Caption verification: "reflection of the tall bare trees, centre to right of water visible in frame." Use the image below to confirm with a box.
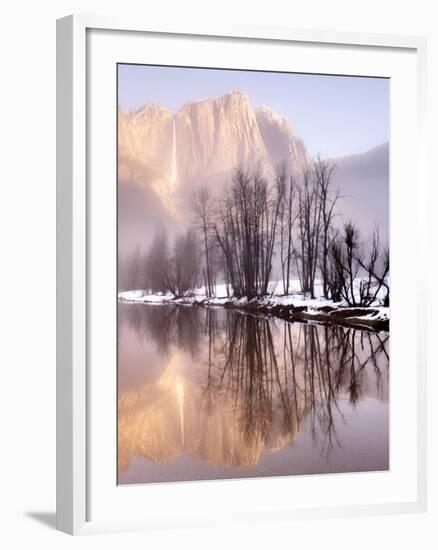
[197,310,389,455]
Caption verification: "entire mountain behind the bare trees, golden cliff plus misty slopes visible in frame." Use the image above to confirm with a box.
[118,92,389,254]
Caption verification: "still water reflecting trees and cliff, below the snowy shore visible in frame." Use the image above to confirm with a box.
[118,303,389,484]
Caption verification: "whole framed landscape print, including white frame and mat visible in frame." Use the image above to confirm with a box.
[57,16,426,534]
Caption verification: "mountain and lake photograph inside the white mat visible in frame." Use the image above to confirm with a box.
[116,63,390,485]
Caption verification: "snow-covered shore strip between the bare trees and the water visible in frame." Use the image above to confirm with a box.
[119,282,389,331]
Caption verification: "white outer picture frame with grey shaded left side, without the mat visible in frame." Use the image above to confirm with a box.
[56,15,427,534]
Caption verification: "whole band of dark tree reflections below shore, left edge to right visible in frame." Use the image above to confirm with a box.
[120,305,389,466]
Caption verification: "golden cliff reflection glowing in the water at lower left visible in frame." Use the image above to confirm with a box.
[118,352,304,473]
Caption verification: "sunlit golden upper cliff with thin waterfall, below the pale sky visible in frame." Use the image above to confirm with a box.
[118,92,308,209]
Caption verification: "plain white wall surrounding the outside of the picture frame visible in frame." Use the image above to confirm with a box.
[0,0,438,550]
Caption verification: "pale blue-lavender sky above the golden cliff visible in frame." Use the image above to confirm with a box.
[118,65,389,158]
